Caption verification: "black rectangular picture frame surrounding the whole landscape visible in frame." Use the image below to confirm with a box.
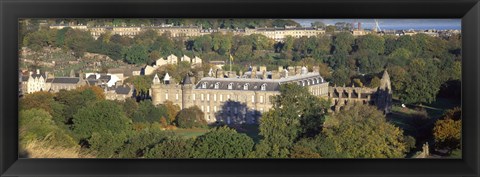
[0,0,480,176]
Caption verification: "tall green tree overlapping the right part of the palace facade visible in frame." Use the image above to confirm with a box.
[256,84,330,158]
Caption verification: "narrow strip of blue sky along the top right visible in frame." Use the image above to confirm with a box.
[293,19,461,30]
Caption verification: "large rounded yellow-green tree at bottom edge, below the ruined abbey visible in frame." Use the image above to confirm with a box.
[320,104,409,158]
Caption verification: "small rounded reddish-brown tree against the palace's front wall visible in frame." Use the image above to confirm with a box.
[176,106,207,128]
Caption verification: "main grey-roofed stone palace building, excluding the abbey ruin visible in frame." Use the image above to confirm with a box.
[152,67,328,124]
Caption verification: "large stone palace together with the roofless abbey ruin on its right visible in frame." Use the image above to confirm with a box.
[150,66,392,124]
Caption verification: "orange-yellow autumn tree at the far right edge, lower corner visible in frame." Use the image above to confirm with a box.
[433,107,462,152]
